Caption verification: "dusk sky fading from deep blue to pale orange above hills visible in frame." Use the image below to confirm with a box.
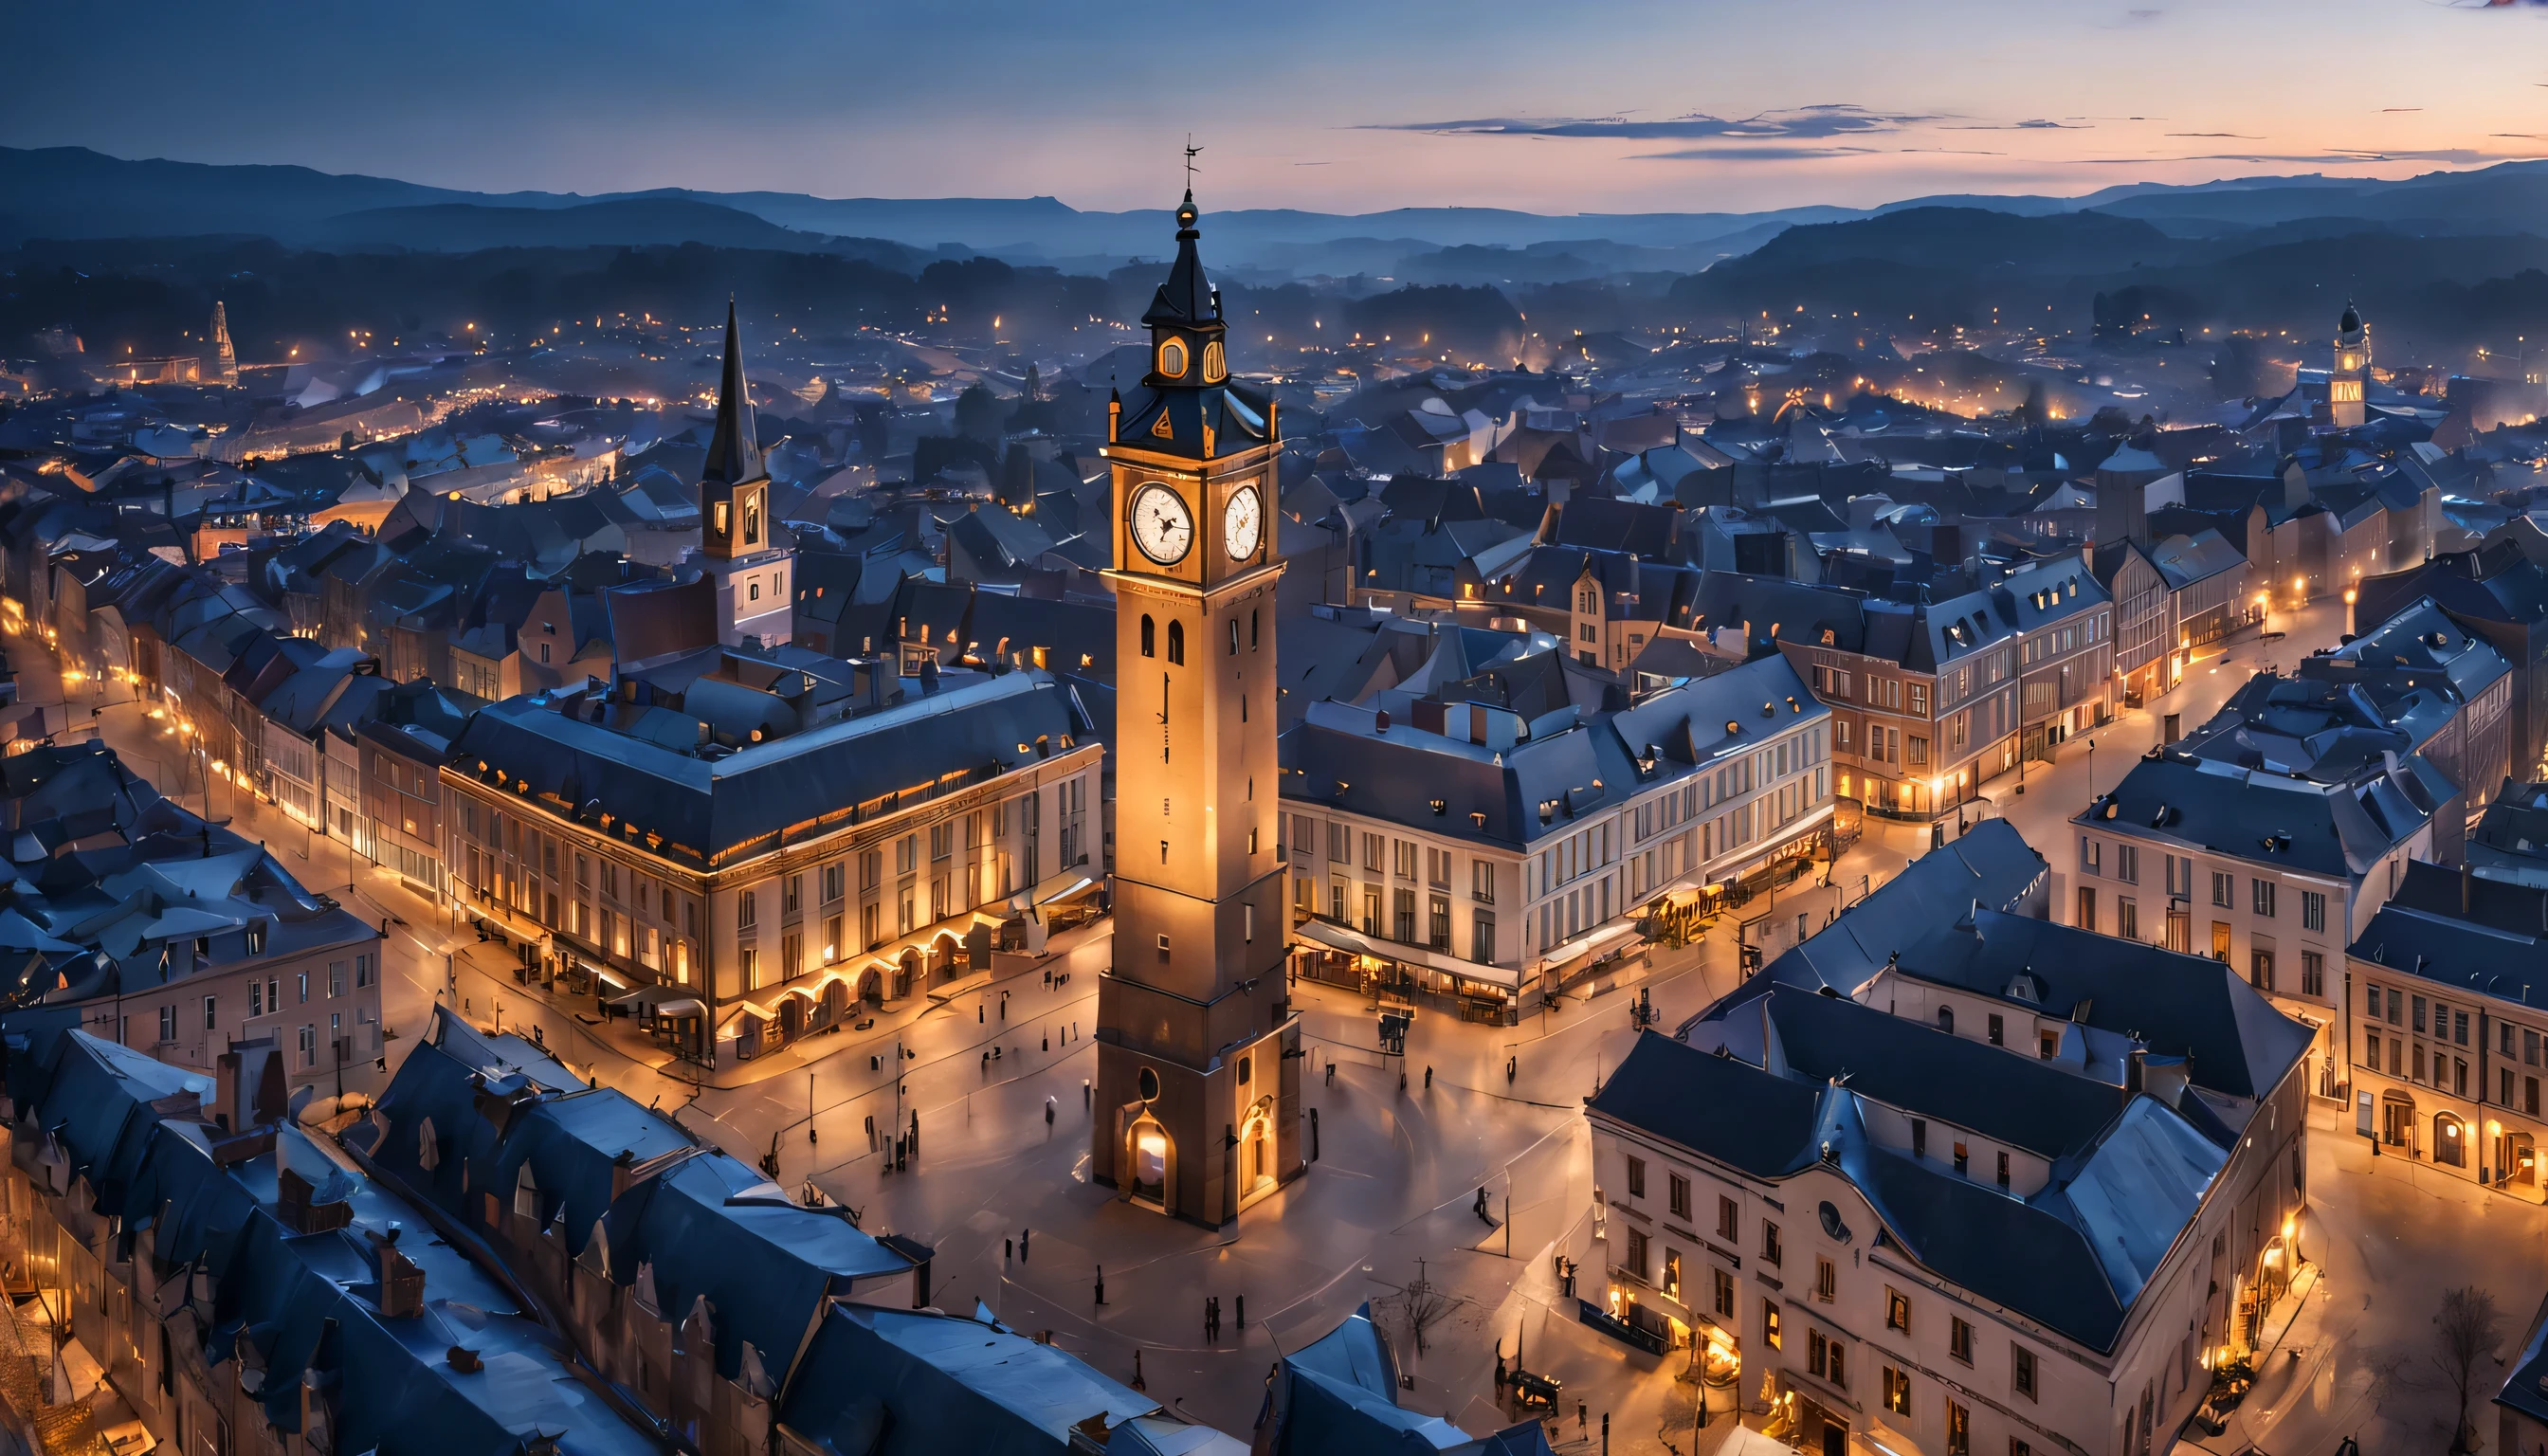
[20,0,2548,211]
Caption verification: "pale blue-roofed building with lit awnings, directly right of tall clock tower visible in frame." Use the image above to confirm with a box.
[1282,642,1832,1023]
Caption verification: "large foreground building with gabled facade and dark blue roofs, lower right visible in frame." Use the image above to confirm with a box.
[1585,910,2308,1456]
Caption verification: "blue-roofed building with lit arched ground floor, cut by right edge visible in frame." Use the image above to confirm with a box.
[2339,864,2548,1201]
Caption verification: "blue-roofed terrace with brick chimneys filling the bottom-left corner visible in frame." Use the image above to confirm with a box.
[0,1028,660,1456]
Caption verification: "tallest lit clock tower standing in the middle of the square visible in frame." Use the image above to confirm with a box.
[1090,191,1302,1227]
